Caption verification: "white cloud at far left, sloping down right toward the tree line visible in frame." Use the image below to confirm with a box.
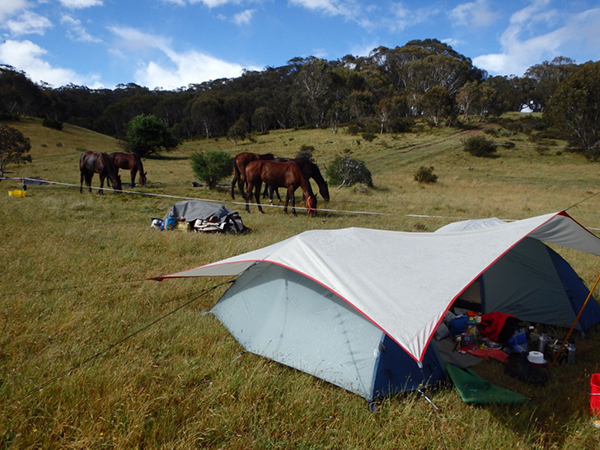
[0,40,100,88]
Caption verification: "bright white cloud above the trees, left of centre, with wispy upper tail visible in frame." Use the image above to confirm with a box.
[111,27,260,89]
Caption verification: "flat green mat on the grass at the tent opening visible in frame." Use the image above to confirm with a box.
[446,363,529,403]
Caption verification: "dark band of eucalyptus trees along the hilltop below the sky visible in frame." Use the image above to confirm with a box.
[0,39,600,153]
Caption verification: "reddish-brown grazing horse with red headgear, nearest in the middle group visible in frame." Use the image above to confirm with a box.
[244,160,317,217]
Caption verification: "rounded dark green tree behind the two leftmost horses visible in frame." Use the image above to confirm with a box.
[125,114,179,158]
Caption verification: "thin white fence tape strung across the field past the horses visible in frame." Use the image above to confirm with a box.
[5,177,600,231]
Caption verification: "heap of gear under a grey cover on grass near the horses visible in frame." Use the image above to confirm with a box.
[151,200,248,233]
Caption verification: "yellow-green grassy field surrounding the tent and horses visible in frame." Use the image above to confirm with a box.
[0,119,600,450]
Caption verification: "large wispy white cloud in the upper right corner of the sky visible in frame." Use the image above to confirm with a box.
[473,0,600,76]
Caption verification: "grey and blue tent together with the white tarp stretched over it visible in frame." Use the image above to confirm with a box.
[159,212,600,399]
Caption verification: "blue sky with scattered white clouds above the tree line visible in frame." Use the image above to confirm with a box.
[0,0,600,89]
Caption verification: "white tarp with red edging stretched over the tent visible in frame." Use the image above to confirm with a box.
[161,212,600,361]
